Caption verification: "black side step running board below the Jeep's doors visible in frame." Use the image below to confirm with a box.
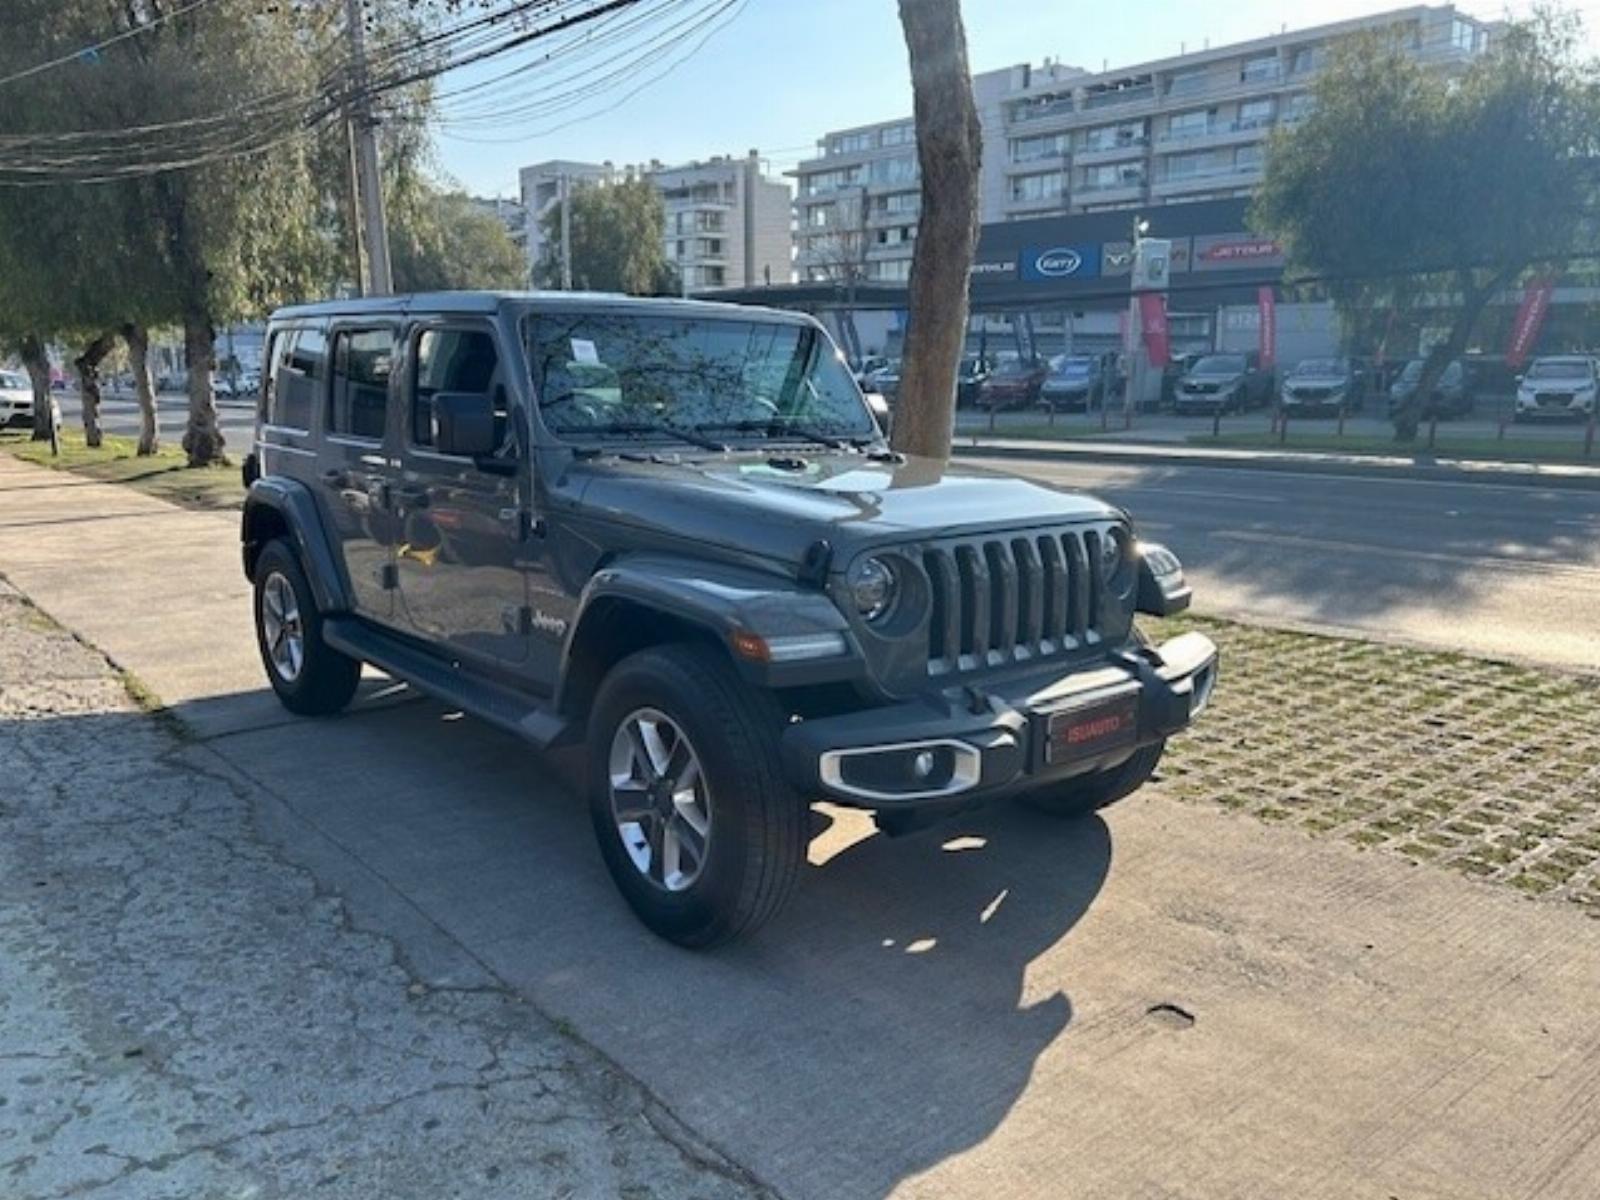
[322,618,576,750]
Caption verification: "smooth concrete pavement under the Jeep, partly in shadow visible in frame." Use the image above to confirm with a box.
[0,456,1600,1200]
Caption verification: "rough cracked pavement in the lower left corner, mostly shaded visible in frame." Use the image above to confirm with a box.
[0,584,758,1200]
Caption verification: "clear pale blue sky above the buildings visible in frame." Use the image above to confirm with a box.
[437,0,1548,195]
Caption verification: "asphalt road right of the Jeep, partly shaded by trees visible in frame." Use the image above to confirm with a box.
[965,459,1600,669]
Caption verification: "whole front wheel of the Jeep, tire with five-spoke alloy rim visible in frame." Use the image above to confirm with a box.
[589,645,806,947]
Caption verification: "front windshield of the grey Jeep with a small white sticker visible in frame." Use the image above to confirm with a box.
[523,312,877,440]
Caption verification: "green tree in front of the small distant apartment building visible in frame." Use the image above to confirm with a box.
[534,179,678,296]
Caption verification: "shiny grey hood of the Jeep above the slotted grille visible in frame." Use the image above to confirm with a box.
[558,451,1118,563]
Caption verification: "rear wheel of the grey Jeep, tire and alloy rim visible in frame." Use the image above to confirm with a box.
[256,539,362,717]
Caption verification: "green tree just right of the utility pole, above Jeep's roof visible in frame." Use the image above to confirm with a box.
[389,195,528,291]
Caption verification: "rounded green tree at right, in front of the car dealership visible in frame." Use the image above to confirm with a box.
[1251,18,1600,440]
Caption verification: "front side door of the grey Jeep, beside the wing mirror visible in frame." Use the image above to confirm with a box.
[394,322,528,664]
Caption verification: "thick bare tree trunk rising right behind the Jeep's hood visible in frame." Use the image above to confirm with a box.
[894,0,982,459]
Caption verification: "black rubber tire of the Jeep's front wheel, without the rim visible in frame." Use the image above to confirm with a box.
[589,643,808,949]
